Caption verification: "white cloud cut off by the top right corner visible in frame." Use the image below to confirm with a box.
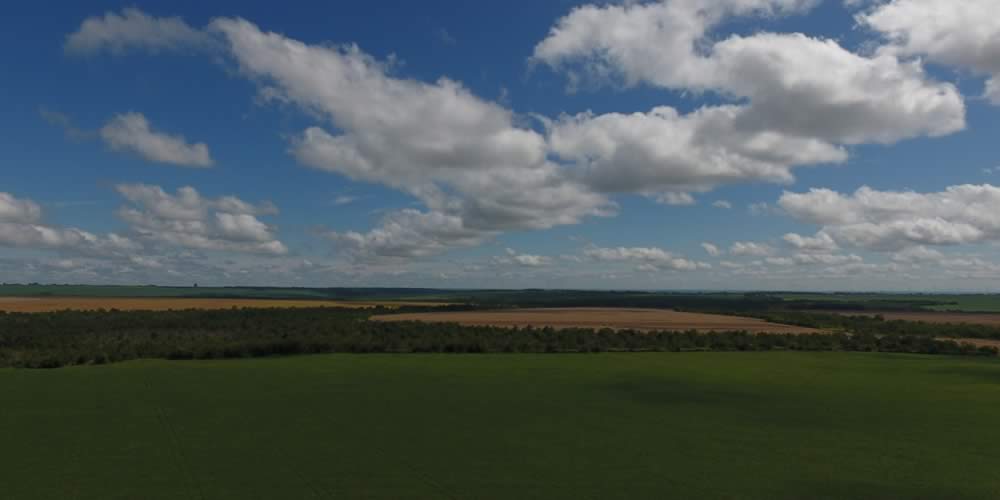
[857,0,1000,105]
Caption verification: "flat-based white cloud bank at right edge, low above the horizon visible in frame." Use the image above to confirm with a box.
[779,184,1000,251]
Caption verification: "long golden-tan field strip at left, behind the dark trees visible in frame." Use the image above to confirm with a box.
[0,297,440,312]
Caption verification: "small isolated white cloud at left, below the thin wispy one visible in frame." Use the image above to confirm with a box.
[100,113,214,167]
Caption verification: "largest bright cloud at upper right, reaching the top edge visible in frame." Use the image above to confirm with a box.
[533,0,964,148]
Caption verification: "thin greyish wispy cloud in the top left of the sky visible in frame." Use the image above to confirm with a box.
[64,8,212,55]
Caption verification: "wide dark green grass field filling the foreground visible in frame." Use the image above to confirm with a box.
[0,353,1000,499]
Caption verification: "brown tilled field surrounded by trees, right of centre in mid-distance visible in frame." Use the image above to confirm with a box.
[372,308,822,333]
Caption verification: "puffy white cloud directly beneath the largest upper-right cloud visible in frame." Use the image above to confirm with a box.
[549,106,847,196]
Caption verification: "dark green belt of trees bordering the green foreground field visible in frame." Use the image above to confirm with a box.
[0,308,997,368]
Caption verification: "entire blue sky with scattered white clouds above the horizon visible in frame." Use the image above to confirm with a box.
[0,0,1000,291]
